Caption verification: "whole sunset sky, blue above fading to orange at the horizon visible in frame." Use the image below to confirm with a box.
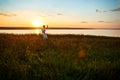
[0,0,120,28]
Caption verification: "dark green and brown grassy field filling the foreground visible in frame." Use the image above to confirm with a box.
[0,34,120,80]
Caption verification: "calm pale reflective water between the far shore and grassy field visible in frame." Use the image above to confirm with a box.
[0,29,120,37]
